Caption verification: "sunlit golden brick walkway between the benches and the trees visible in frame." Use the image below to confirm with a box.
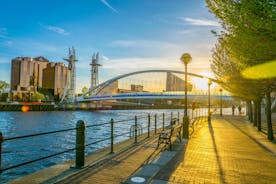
[153,117,276,184]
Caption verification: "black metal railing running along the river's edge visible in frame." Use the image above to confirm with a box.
[0,111,204,180]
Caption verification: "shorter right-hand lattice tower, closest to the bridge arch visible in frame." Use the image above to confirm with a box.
[90,53,101,89]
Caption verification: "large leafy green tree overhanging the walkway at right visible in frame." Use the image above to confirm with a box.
[206,0,276,140]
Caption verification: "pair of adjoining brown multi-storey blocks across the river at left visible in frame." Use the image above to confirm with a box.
[10,56,68,101]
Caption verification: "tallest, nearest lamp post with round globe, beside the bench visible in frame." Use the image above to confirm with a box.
[180,53,192,139]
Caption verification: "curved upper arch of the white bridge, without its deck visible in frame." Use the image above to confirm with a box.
[79,70,219,99]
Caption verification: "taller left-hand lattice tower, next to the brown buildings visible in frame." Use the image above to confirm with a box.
[61,47,78,103]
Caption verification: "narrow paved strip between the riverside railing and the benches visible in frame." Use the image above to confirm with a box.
[58,139,160,184]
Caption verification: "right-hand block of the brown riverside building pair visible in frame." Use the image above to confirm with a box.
[42,63,69,99]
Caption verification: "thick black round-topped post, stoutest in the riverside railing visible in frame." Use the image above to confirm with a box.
[75,120,85,169]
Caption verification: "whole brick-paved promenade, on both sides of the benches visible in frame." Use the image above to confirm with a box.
[11,116,276,184]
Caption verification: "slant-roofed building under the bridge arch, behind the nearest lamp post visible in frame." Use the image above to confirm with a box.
[166,72,192,92]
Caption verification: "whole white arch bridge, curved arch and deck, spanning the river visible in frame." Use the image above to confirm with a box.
[76,70,231,102]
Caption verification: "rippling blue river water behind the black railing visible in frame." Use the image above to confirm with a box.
[0,109,233,183]
